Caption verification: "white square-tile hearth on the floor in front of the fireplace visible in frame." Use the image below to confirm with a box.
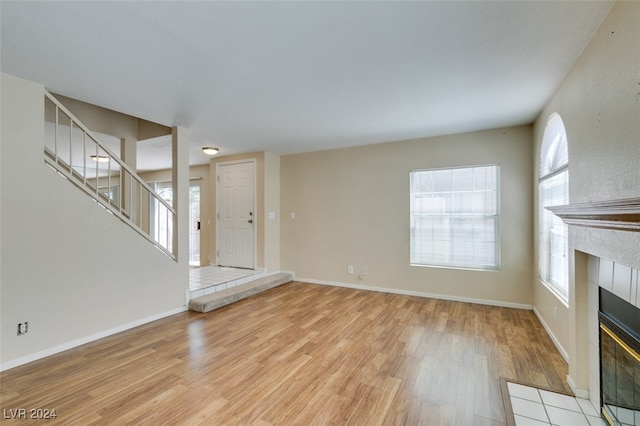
[507,382,606,426]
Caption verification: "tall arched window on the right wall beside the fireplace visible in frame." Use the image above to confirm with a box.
[538,113,569,303]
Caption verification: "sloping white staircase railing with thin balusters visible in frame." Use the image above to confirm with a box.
[44,91,176,260]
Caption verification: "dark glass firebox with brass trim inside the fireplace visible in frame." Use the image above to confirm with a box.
[598,287,640,426]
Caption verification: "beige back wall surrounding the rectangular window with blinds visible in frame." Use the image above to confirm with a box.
[281,126,533,305]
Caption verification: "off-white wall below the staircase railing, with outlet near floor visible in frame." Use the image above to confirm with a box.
[0,74,188,369]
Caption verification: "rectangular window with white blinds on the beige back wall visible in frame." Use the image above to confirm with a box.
[410,165,500,270]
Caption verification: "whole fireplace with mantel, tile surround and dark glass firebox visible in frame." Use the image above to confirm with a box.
[547,197,640,426]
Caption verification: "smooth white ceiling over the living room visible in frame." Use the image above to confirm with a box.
[0,1,613,168]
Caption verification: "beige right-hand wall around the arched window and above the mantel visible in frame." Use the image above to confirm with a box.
[534,1,640,389]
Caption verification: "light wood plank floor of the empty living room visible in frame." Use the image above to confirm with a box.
[0,282,569,426]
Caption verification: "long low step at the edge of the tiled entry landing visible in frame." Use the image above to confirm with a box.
[189,273,293,312]
